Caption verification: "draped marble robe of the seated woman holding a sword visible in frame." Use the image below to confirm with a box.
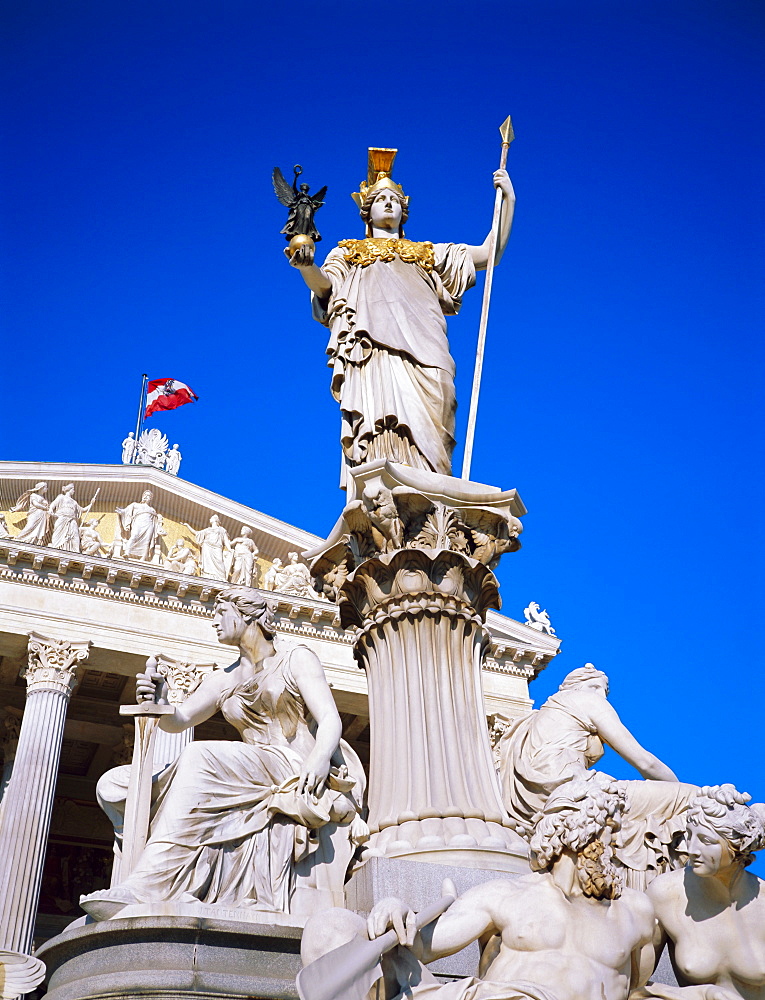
[89,649,367,919]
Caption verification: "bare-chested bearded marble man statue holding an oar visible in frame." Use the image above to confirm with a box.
[301,774,654,1000]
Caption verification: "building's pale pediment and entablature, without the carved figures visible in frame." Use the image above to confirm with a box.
[0,462,560,708]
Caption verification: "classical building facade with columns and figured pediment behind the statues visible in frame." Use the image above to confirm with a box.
[0,462,559,952]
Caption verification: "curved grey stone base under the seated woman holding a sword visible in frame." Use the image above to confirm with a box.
[40,907,301,1000]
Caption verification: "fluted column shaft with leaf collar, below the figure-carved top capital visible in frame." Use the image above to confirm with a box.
[350,549,515,856]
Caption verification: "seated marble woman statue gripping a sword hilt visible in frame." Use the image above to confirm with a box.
[81,589,366,920]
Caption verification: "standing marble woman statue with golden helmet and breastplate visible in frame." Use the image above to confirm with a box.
[289,150,515,487]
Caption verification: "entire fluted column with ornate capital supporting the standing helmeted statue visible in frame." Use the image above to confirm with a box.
[306,461,527,870]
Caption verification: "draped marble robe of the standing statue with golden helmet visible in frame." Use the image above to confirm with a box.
[313,241,475,487]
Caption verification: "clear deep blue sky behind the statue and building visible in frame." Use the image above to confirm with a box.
[0,0,765,868]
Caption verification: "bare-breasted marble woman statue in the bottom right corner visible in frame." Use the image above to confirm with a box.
[635,785,765,1000]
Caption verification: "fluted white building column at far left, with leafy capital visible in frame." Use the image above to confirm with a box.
[0,632,91,995]
